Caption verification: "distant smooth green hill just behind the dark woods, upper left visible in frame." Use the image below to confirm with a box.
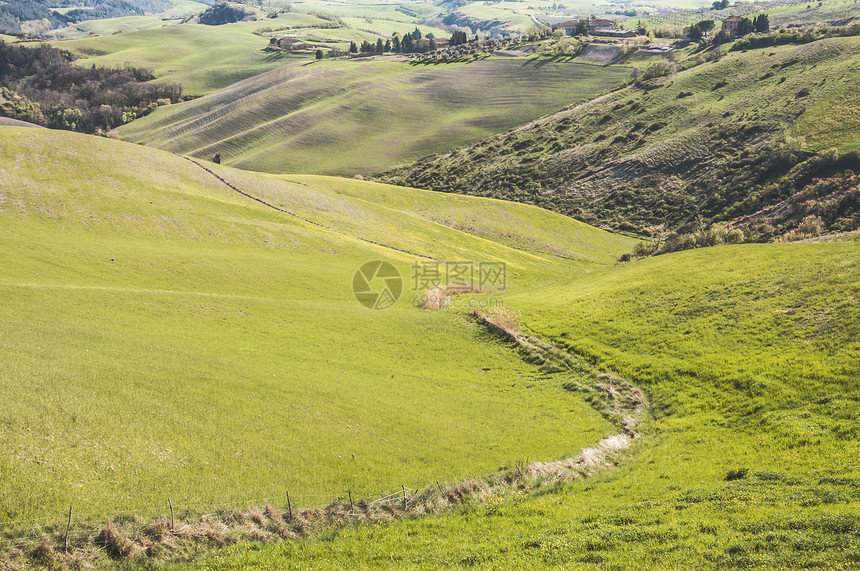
[47,12,445,96]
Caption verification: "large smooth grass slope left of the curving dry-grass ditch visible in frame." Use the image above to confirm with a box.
[0,128,631,529]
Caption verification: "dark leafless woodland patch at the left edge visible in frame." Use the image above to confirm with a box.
[0,41,182,133]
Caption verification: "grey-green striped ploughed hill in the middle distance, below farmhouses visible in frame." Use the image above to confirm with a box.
[116,58,630,176]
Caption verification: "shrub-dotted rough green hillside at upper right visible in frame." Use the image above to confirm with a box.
[379,37,860,238]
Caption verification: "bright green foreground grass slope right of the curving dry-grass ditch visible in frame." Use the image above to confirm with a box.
[178,237,860,569]
